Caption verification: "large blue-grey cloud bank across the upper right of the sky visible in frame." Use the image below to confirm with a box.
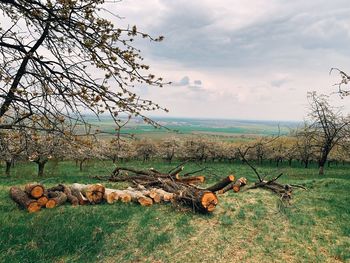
[144,0,350,68]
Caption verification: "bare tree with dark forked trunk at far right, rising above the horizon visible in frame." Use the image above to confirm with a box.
[309,92,350,175]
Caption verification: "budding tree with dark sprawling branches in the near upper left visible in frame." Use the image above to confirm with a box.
[0,0,166,132]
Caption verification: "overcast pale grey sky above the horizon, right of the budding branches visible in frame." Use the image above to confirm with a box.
[106,0,350,121]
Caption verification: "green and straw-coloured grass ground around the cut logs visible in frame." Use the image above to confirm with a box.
[0,161,350,263]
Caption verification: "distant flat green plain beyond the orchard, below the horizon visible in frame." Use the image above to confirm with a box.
[84,117,299,139]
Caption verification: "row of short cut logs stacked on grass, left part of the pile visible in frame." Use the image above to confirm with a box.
[10,183,179,213]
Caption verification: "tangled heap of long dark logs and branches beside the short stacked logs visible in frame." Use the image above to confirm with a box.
[95,166,246,213]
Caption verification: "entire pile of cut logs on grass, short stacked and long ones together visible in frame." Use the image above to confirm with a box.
[10,168,247,213]
